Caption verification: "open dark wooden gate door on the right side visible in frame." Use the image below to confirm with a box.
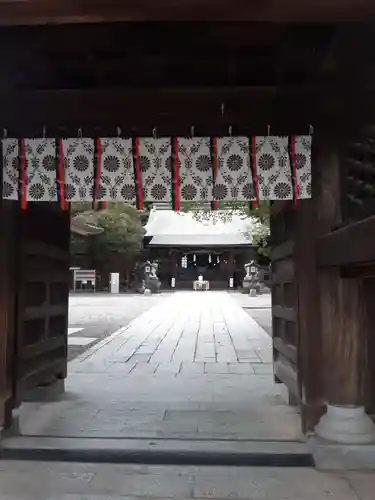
[271,200,322,432]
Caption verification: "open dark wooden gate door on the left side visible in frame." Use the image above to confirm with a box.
[14,203,70,405]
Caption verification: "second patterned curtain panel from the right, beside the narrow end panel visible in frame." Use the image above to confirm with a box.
[256,136,293,200]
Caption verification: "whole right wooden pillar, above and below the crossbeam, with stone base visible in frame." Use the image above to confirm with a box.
[314,131,375,443]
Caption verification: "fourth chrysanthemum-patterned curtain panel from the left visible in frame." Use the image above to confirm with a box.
[96,137,136,202]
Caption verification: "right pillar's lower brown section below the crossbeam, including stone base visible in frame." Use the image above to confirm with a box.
[315,269,375,443]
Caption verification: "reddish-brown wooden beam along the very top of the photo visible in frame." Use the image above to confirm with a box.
[0,0,374,25]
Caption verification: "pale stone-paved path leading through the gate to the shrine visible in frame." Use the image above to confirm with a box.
[17,292,302,440]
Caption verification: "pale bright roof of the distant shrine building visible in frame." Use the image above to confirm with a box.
[145,209,259,247]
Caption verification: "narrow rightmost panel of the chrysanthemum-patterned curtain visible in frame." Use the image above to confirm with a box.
[295,135,312,199]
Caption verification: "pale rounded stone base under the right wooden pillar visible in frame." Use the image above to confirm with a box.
[315,405,375,444]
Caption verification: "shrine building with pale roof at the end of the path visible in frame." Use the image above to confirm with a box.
[145,205,257,290]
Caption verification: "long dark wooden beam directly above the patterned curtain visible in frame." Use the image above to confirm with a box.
[0,87,334,136]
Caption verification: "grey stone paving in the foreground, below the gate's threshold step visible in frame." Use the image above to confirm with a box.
[0,461,375,500]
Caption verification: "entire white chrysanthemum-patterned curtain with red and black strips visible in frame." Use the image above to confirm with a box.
[2,135,312,203]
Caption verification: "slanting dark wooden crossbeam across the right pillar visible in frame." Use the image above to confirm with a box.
[318,216,375,267]
